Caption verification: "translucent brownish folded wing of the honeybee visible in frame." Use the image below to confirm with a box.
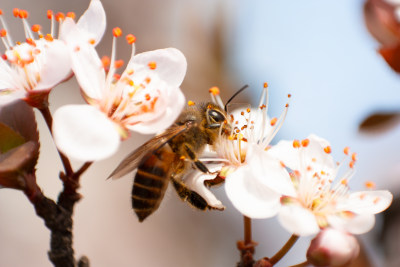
[107,124,189,179]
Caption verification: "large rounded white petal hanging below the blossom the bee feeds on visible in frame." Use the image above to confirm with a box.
[225,165,281,219]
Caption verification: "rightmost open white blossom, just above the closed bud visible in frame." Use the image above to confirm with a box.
[264,135,393,236]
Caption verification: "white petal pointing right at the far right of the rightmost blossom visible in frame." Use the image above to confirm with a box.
[337,190,393,214]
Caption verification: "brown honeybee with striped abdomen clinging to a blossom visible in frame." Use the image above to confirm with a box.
[109,103,231,222]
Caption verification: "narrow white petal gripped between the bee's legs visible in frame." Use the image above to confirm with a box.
[184,164,225,210]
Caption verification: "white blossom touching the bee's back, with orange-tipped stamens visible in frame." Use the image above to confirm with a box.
[53,21,187,161]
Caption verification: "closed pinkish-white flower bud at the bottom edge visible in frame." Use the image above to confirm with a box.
[307,228,360,267]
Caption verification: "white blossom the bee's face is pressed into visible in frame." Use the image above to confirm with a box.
[215,85,293,218]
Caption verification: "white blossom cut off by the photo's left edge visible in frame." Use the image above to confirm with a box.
[0,0,105,107]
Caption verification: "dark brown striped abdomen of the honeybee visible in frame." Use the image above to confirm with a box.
[132,144,179,222]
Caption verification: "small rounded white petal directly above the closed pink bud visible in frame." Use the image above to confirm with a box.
[278,205,319,236]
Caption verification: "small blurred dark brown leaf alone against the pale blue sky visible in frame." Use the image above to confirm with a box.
[359,112,400,133]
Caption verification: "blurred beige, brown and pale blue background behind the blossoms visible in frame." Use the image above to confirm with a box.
[0,0,400,267]
